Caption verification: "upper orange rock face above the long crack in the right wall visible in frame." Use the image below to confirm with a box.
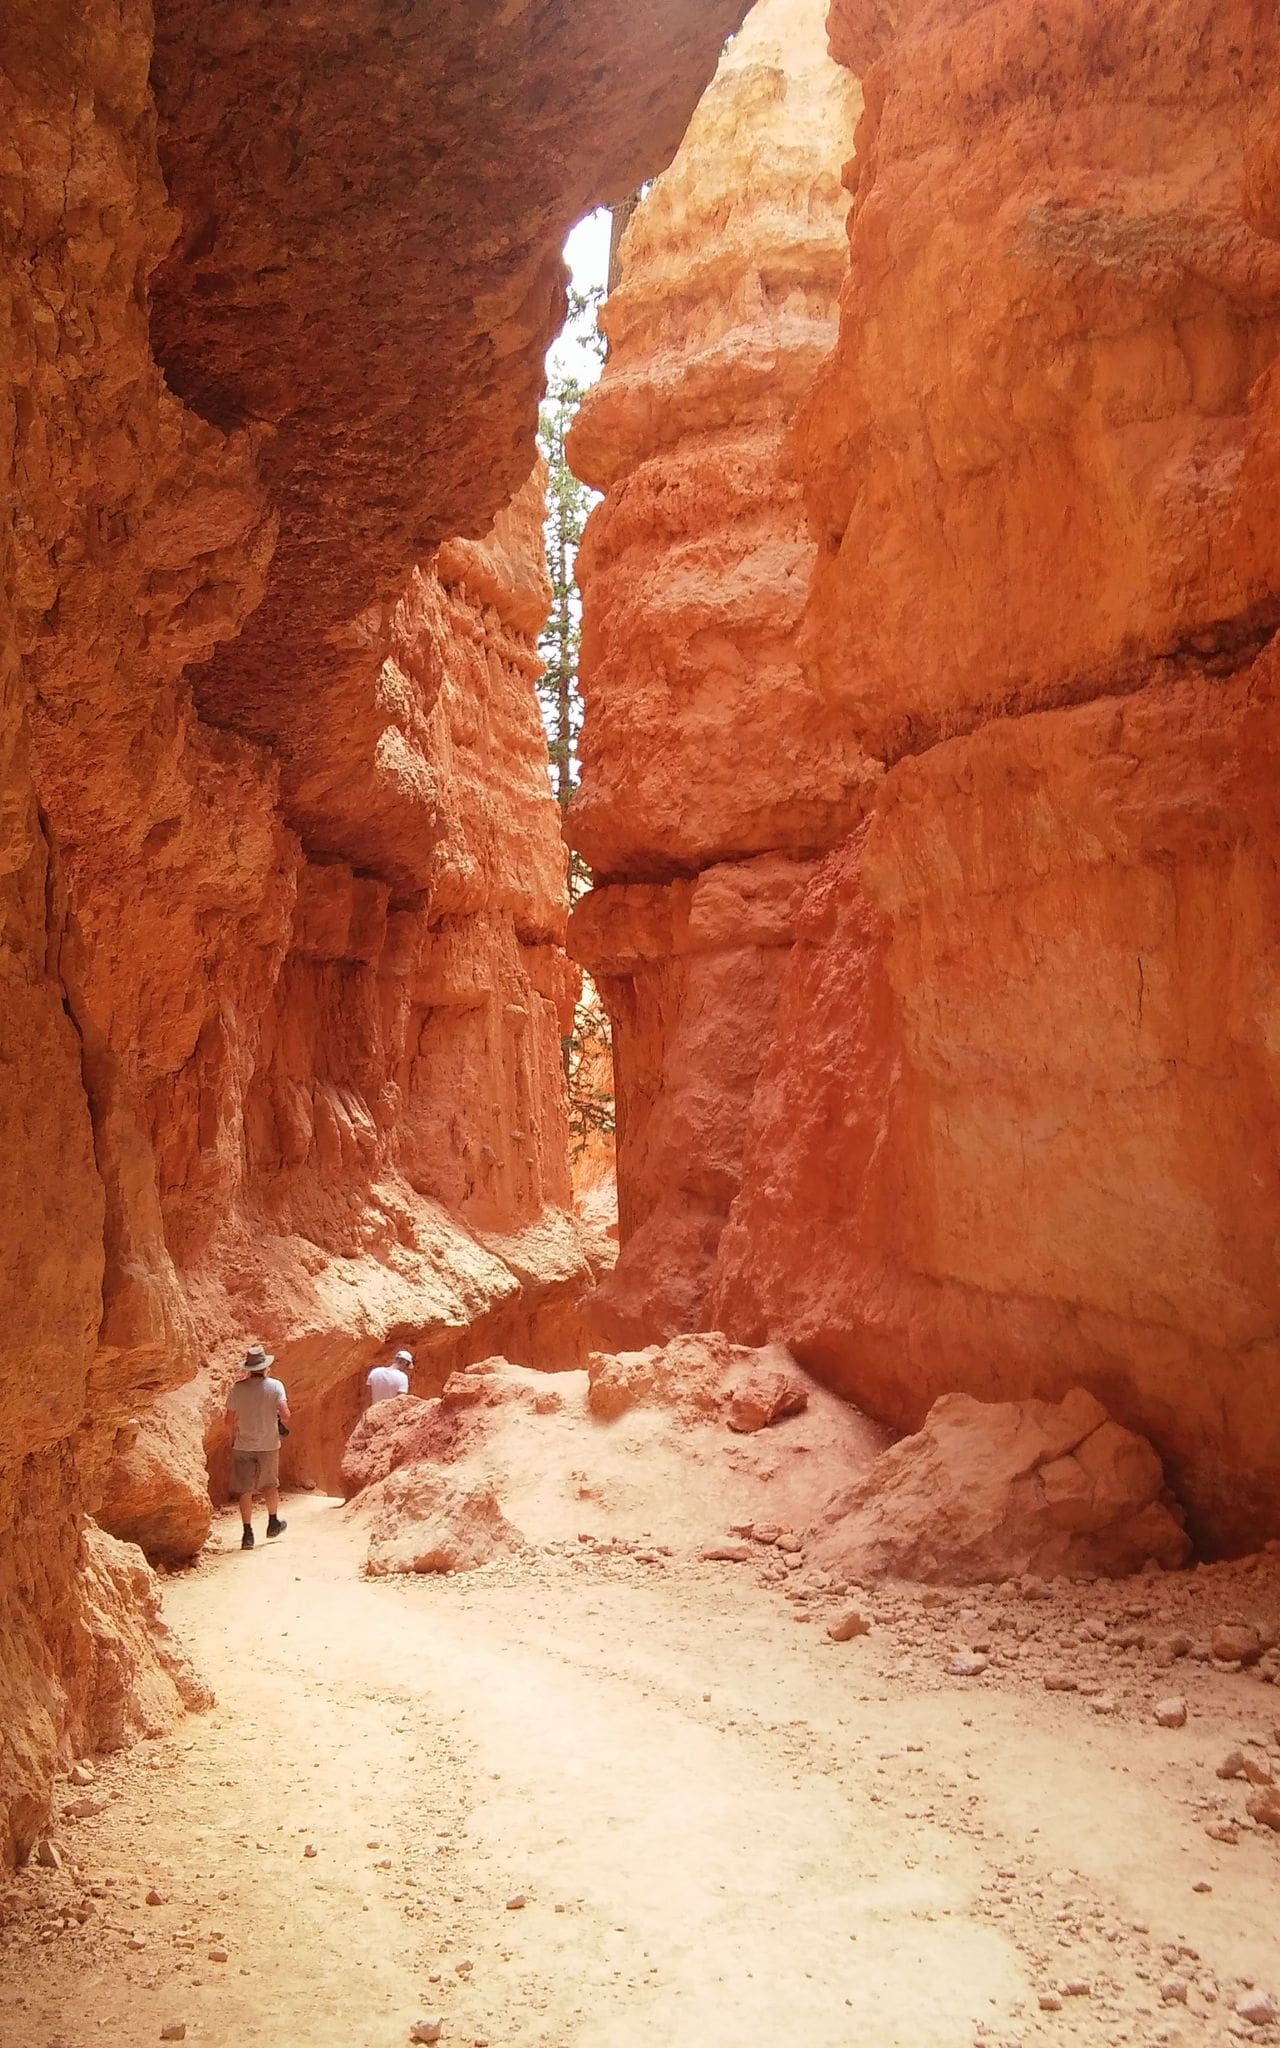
[799,0,1280,758]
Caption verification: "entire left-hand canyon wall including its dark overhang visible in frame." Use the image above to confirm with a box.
[0,0,741,1853]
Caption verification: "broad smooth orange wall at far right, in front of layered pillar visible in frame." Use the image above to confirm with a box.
[573,0,1280,1546]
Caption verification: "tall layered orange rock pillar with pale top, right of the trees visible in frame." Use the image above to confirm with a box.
[569,0,870,1343]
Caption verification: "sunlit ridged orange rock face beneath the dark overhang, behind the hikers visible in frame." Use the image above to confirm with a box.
[102,468,588,1523]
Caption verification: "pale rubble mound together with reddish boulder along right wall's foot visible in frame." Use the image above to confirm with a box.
[342,1331,1190,1583]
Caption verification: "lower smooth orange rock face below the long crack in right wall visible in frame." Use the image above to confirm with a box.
[719,664,1280,1540]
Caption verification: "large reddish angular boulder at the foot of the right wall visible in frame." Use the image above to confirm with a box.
[815,1389,1190,1585]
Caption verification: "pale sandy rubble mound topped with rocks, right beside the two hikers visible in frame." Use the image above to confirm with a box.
[342,1331,885,1573]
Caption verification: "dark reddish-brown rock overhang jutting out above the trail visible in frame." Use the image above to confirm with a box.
[154,0,745,881]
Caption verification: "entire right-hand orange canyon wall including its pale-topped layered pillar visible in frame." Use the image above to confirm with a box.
[573,0,1280,1546]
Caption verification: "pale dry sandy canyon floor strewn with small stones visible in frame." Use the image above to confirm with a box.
[0,1497,1280,2048]
